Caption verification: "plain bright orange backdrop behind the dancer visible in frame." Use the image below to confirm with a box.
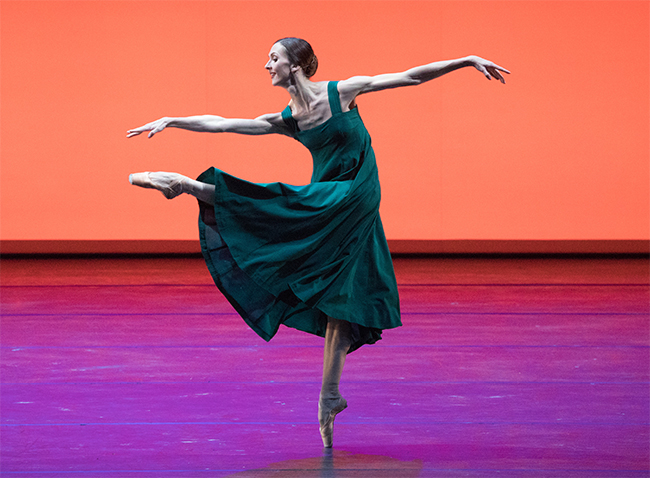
[0,0,650,239]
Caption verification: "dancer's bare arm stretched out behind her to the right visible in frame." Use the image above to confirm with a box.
[339,56,510,101]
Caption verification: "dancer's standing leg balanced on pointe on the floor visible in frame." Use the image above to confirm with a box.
[318,317,352,447]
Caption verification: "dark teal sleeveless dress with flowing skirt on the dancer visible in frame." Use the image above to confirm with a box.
[198,82,401,352]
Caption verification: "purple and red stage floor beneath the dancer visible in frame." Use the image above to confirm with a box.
[0,257,650,478]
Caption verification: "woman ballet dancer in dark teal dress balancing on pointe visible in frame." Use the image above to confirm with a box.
[128,38,509,447]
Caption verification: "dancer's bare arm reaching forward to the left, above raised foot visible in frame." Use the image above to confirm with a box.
[126,113,291,138]
